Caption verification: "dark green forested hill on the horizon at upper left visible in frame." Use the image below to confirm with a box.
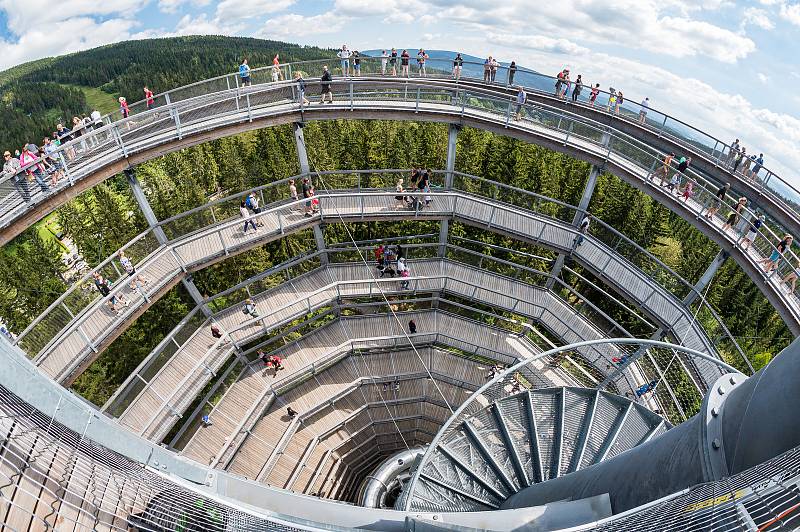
[0,36,333,150]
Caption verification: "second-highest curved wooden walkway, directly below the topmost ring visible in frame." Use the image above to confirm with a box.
[21,192,728,385]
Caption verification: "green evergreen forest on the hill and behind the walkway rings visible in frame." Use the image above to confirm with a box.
[0,37,791,405]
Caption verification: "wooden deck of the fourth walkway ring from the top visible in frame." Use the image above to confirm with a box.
[177,311,566,463]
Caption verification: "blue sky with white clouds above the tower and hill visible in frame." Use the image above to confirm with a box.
[0,0,800,188]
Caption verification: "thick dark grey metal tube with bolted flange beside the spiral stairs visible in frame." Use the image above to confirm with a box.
[502,340,800,513]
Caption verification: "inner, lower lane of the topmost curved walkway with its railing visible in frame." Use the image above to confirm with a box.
[0,80,800,334]
